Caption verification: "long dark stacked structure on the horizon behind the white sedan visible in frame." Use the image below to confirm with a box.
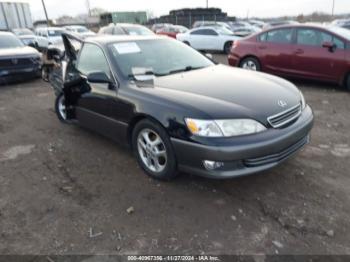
[148,8,236,27]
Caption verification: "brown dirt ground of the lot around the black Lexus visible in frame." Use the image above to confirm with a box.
[0,53,350,254]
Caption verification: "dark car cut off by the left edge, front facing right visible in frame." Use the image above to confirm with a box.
[0,32,41,84]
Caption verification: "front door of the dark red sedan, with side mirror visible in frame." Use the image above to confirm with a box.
[294,28,346,81]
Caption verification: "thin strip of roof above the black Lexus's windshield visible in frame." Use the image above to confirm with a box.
[84,35,169,45]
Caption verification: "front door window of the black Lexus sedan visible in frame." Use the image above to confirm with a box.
[77,44,111,76]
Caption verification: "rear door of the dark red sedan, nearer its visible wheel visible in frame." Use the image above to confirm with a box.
[257,27,294,74]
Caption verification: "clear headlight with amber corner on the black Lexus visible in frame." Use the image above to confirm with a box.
[186,118,266,137]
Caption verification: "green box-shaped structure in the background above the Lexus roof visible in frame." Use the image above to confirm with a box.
[100,12,147,25]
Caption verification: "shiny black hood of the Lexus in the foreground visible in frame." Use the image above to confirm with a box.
[148,65,301,123]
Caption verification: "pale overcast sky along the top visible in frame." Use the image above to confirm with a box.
[13,0,350,20]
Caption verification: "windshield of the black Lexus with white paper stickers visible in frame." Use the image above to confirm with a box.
[109,39,214,78]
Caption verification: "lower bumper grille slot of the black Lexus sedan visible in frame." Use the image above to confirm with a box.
[244,136,309,167]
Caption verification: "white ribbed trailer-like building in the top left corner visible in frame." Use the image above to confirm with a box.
[0,1,33,30]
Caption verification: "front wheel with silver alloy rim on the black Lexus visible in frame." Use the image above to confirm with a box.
[132,119,177,180]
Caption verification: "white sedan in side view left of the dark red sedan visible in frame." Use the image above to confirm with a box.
[176,27,241,54]
